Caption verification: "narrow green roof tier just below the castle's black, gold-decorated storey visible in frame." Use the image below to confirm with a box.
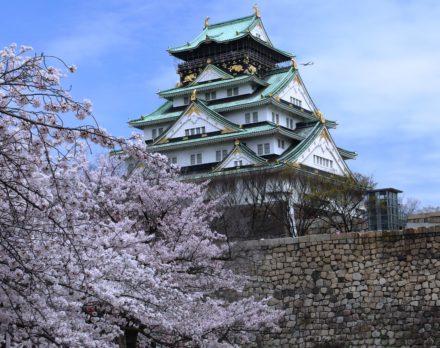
[158,75,268,98]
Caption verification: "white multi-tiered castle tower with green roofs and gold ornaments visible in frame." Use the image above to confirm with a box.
[129,6,356,179]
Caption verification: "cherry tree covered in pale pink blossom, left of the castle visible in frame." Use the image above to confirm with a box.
[0,45,280,347]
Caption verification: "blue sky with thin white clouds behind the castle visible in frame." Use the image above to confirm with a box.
[0,0,440,206]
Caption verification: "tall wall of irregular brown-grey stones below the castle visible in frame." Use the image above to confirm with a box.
[232,226,440,347]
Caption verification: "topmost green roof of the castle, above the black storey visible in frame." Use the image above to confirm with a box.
[168,15,293,58]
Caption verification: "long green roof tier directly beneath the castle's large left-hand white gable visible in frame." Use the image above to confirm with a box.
[149,123,303,151]
